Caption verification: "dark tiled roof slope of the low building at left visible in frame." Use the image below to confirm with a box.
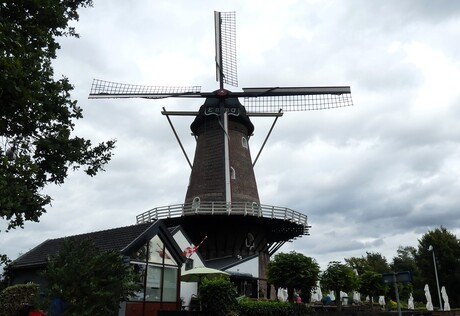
[13,223,154,268]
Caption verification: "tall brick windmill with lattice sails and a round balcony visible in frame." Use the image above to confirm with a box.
[89,12,352,286]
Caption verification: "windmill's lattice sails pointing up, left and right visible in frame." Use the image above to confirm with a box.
[89,11,353,113]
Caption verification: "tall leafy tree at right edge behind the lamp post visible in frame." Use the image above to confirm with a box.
[415,226,460,307]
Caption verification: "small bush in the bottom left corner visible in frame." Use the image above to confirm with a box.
[0,284,38,316]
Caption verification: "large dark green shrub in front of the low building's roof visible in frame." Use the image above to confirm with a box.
[44,239,136,316]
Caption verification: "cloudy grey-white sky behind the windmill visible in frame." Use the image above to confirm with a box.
[0,0,460,268]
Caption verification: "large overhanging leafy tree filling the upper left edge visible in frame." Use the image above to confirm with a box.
[0,0,114,229]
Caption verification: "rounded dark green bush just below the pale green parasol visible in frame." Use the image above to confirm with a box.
[199,277,238,316]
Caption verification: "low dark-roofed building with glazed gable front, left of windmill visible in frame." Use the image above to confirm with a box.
[9,220,196,316]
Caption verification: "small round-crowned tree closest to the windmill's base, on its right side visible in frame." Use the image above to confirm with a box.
[267,251,320,298]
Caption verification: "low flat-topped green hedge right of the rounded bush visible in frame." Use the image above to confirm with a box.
[238,299,311,316]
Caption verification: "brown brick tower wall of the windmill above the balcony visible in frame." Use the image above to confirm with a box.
[185,105,260,204]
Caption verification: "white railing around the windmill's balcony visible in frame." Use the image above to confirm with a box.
[136,201,310,234]
